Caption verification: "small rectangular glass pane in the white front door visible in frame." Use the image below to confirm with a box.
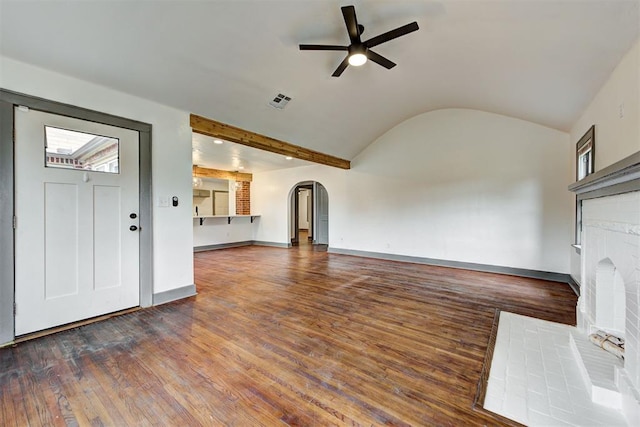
[44,126,120,173]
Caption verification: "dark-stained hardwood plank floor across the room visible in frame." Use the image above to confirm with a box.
[0,246,576,426]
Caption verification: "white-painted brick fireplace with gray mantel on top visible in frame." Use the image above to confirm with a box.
[569,153,640,425]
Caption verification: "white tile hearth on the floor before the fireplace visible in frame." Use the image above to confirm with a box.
[483,311,627,426]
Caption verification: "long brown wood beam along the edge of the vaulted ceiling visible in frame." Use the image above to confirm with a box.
[190,114,351,169]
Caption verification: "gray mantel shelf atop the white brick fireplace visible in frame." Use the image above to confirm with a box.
[569,152,640,200]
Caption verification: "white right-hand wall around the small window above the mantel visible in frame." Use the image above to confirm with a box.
[569,40,640,282]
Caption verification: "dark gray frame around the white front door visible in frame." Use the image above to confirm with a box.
[0,88,153,345]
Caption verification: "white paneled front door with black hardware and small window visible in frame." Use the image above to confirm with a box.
[15,108,140,336]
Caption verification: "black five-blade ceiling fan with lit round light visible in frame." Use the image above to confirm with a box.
[300,6,418,77]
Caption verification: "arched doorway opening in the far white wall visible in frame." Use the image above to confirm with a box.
[289,181,329,247]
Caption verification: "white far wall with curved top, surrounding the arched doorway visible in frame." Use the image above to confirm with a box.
[251,109,572,273]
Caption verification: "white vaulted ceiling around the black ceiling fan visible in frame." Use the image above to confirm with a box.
[0,0,640,171]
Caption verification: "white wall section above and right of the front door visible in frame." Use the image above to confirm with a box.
[0,57,193,293]
